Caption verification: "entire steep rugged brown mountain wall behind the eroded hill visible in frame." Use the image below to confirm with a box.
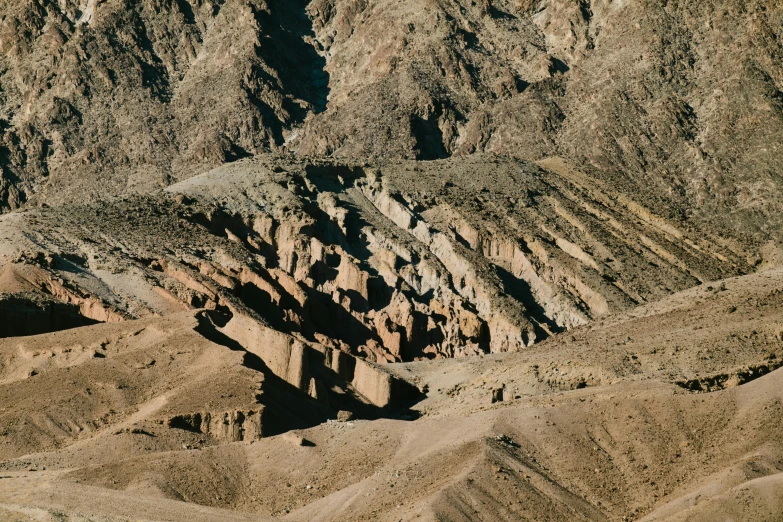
[0,0,783,242]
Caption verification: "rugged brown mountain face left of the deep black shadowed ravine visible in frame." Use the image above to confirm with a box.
[0,0,326,208]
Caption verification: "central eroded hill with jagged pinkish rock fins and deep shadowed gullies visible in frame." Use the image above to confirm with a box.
[0,156,749,368]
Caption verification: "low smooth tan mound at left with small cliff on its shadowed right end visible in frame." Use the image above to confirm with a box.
[0,308,336,458]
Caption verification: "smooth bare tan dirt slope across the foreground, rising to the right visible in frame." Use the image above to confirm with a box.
[0,270,783,520]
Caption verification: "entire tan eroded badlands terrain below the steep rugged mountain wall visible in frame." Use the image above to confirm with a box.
[0,155,783,520]
